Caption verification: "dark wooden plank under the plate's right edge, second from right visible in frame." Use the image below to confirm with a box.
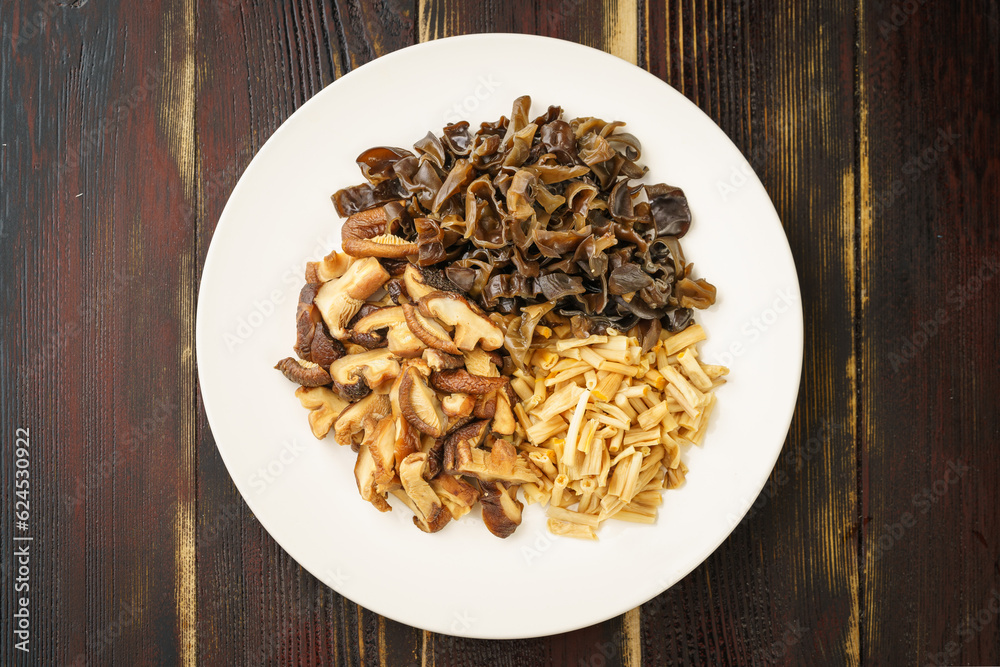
[639,0,859,665]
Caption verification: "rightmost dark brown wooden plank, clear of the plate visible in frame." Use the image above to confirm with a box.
[858,1,1000,665]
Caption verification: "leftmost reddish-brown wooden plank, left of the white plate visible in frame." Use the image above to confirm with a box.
[0,0,195,664]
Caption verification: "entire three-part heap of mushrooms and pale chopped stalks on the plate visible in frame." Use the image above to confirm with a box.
[276,97,726,539]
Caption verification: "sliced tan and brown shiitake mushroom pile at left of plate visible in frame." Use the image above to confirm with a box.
[276,252,540,537]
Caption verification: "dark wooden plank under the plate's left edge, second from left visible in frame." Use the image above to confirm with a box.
[195,0,423,665]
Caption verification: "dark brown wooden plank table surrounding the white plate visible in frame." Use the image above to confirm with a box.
[0,0,1000,667]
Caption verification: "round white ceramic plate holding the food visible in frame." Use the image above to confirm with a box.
[197,35,802,639]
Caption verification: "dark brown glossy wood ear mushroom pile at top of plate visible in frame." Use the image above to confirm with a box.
[333,96,715,367]
